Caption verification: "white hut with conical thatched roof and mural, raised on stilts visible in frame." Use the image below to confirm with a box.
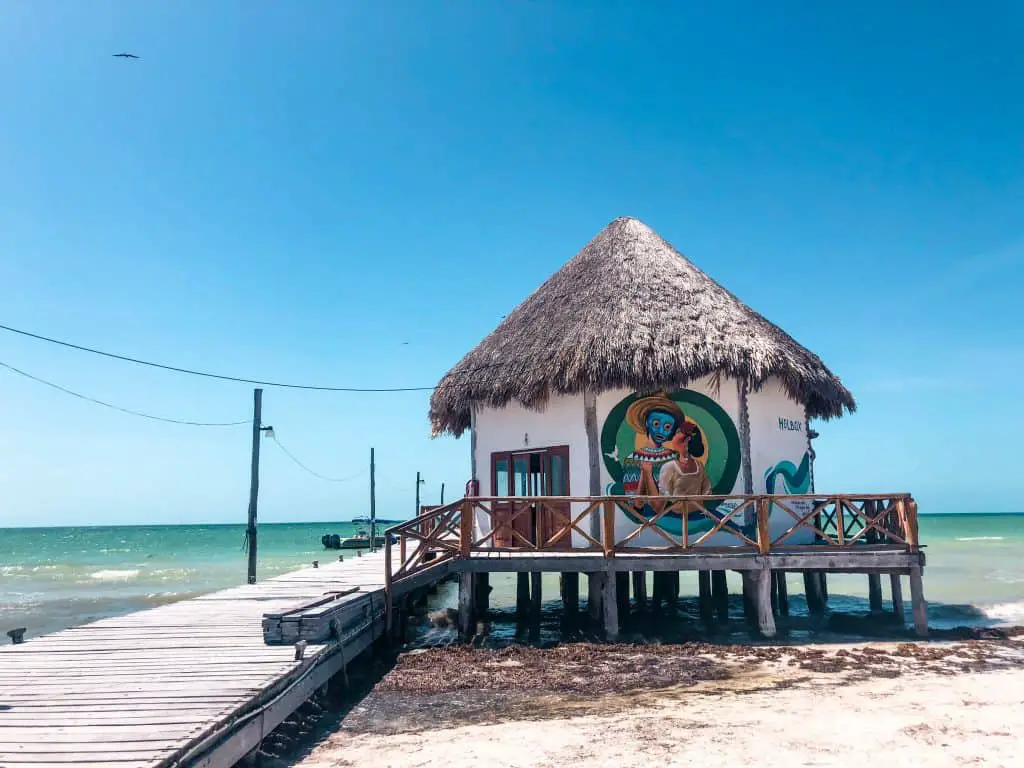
[385,218,923,634]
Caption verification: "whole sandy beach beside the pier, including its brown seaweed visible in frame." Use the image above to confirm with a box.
[263,636,1024,768]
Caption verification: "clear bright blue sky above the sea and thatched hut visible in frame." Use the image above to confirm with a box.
[0,0,1024,525]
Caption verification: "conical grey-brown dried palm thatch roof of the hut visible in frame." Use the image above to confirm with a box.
[430,218,856,435]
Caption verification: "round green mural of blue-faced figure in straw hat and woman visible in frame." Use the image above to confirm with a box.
[601,389,740,536]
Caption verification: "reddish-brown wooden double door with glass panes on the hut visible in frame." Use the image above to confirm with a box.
[490,445,572,549]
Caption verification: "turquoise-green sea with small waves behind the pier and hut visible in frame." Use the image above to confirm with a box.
[0,514,1024,635]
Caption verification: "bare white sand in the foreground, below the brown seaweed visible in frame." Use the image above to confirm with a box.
[288,668,1024,768]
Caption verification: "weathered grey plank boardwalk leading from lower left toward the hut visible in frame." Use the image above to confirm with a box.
[0,553,397,768]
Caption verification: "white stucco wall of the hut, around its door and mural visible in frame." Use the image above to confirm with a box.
[475,378,823,546]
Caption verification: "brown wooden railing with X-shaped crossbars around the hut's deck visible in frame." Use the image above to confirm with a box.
[385,494,920,583]
